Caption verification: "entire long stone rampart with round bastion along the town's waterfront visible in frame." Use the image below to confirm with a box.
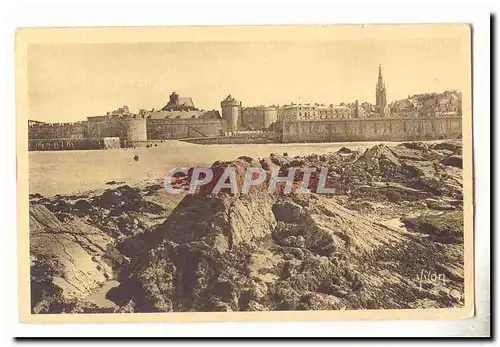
[28,117,462,151]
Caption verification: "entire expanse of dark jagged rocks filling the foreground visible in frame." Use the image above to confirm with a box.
[30,141,464,313]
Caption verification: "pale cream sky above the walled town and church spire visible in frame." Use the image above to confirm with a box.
[27,38,464,122]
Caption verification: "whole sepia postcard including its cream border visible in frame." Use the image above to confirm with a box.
[16,24,474,322]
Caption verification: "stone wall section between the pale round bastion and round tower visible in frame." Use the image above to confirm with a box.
[147,119,226,140]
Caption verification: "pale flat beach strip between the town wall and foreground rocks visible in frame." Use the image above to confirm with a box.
[29,140,459,196]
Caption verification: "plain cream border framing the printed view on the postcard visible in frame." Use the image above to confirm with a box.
[16,24,474,323]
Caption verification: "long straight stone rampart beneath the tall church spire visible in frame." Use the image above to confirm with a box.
[282,117,462,143]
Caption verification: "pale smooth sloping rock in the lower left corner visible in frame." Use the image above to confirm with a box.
[30,205,114,312]
